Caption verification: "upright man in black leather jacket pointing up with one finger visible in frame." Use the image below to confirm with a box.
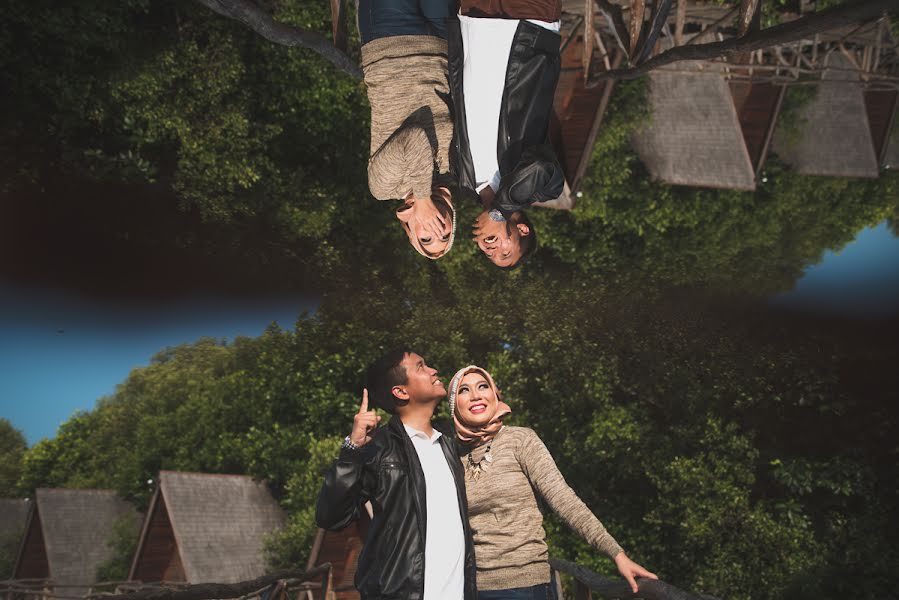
[315,350,477,600]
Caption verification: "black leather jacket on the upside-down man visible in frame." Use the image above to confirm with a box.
[447,12,565,218]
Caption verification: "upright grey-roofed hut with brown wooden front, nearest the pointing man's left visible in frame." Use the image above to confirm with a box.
[128,471,285,583]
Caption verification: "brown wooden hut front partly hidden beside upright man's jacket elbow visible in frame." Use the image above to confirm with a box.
[306,513,370,600]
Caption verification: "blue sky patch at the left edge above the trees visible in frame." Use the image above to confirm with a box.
[0,280,315,445]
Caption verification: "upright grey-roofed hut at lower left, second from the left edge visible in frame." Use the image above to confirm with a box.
[13,489,135,586]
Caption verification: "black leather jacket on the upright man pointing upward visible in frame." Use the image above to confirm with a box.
[315,417,477,600]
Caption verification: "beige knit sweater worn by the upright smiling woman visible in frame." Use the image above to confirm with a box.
[462,426,621,590]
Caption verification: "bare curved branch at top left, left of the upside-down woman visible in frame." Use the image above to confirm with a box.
[196,0,362,79]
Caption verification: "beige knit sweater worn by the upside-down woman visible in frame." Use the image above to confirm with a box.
[362,35,453,200]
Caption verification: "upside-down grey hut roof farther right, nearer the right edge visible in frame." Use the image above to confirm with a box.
[774,52,878,178]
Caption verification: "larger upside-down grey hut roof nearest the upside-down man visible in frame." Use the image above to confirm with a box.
[632,62,755,190]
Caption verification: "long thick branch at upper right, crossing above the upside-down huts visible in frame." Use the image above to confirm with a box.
[588,0,897,86]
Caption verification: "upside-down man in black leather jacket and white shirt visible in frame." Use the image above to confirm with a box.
[447,5,565,267]
